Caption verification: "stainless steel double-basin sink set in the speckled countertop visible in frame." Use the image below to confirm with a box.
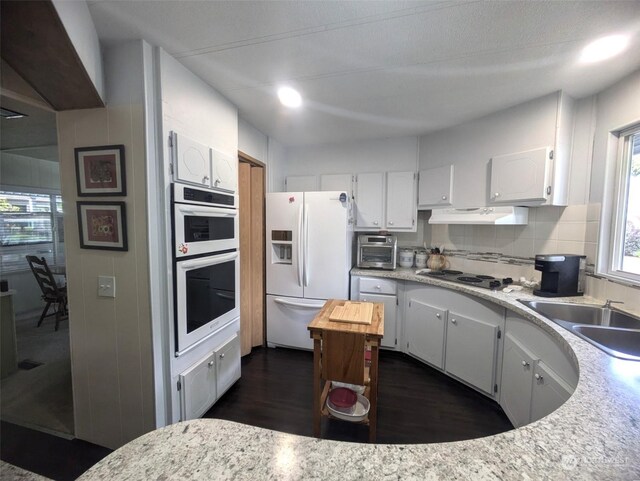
[519,299,640,361]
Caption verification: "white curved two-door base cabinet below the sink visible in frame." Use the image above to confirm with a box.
[500,313,578,427]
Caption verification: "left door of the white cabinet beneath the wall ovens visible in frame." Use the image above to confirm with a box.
[180,348,217,421]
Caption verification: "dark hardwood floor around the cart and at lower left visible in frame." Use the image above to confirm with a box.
[0,348,513,480]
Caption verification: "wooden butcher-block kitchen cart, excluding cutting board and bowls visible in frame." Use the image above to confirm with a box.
[308,299,384,442]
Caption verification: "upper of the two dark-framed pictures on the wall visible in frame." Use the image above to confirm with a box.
[75,145,127,197]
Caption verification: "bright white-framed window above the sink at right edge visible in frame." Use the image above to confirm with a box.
[607,125,640,284]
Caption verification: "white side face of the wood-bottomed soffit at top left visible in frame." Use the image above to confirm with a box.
[53,0,105,100]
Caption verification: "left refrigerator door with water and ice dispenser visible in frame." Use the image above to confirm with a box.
[265,192,304,297]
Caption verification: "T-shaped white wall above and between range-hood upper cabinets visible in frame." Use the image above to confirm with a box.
[419,93,558,208]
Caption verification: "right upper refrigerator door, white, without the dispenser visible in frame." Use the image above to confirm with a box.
[302,191,353,299]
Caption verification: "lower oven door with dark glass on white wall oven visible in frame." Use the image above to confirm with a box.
[175,251,240,355]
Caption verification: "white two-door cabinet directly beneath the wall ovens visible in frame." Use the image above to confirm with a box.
[180,334,240,421]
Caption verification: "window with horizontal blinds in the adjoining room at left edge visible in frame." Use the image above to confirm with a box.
[0,191,64,272]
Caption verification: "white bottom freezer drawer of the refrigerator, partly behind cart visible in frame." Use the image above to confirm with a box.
[267,296,325,349]
